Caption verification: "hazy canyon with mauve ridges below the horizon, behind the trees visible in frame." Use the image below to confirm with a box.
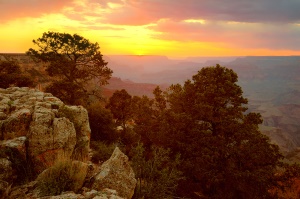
[0,54,300,160]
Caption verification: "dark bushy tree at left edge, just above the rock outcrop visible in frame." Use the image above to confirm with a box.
[0,61,36,88]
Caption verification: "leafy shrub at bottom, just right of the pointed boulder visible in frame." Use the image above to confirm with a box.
[131,144,183,199]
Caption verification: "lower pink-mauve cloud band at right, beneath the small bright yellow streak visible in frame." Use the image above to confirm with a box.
[152,19,300,50]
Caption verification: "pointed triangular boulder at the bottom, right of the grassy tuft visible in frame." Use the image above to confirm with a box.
[92,147,136,199]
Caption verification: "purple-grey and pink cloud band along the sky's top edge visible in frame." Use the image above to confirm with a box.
[102,0,300,25]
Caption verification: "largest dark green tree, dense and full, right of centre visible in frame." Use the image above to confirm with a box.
[157,65,282,198]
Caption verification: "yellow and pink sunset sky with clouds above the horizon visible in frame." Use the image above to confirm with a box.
[0,0,300,58]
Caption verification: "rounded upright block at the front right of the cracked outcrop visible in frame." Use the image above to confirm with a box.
[28,113,76,171]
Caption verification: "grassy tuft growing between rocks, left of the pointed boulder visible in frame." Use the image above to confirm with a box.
[37,158,88,196]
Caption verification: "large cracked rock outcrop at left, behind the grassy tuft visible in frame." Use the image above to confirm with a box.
[0,87,90,180]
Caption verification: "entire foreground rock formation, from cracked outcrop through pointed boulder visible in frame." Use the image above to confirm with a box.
[0,87,136,199]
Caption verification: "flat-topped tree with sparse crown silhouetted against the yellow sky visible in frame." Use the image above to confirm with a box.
[27,32,112,104]
